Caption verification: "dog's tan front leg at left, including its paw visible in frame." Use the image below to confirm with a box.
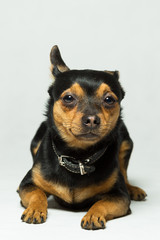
[18,171,48,223]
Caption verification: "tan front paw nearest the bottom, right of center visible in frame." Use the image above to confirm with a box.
[81,212,106,230]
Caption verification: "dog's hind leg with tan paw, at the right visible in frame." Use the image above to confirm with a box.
[119,126,147,201]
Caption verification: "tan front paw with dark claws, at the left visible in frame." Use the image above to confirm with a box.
[21,205,47,224]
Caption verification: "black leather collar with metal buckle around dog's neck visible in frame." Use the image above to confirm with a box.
[52,140,108,175]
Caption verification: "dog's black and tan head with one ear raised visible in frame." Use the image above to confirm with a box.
[49,46,124,149]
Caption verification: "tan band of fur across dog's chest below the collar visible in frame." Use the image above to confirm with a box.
[32,167,117,203]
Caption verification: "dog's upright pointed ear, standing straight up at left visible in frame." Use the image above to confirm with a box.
[50,45,70,77]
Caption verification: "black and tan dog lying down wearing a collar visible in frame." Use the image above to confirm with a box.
[19,46,146,229]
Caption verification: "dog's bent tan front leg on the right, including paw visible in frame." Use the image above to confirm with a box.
[81,197,130,230]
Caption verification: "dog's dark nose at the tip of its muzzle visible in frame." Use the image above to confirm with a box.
[82,115,100,129]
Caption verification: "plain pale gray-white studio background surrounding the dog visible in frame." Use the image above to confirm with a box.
[0,0,160,239]
